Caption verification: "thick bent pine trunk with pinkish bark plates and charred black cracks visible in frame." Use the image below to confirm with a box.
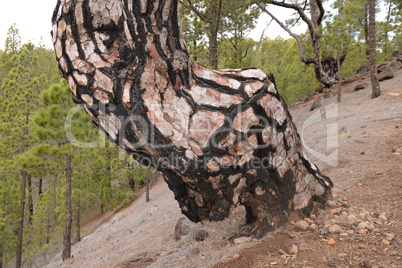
[53,0,332,237]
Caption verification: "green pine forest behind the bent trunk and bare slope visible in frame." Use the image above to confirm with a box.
[0,0,402,267]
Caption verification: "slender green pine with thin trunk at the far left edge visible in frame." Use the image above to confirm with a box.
[0,44,46,267]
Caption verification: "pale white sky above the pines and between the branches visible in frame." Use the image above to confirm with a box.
[0,0,305,50]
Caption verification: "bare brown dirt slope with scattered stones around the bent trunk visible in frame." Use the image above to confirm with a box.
[46,61,402,268]
